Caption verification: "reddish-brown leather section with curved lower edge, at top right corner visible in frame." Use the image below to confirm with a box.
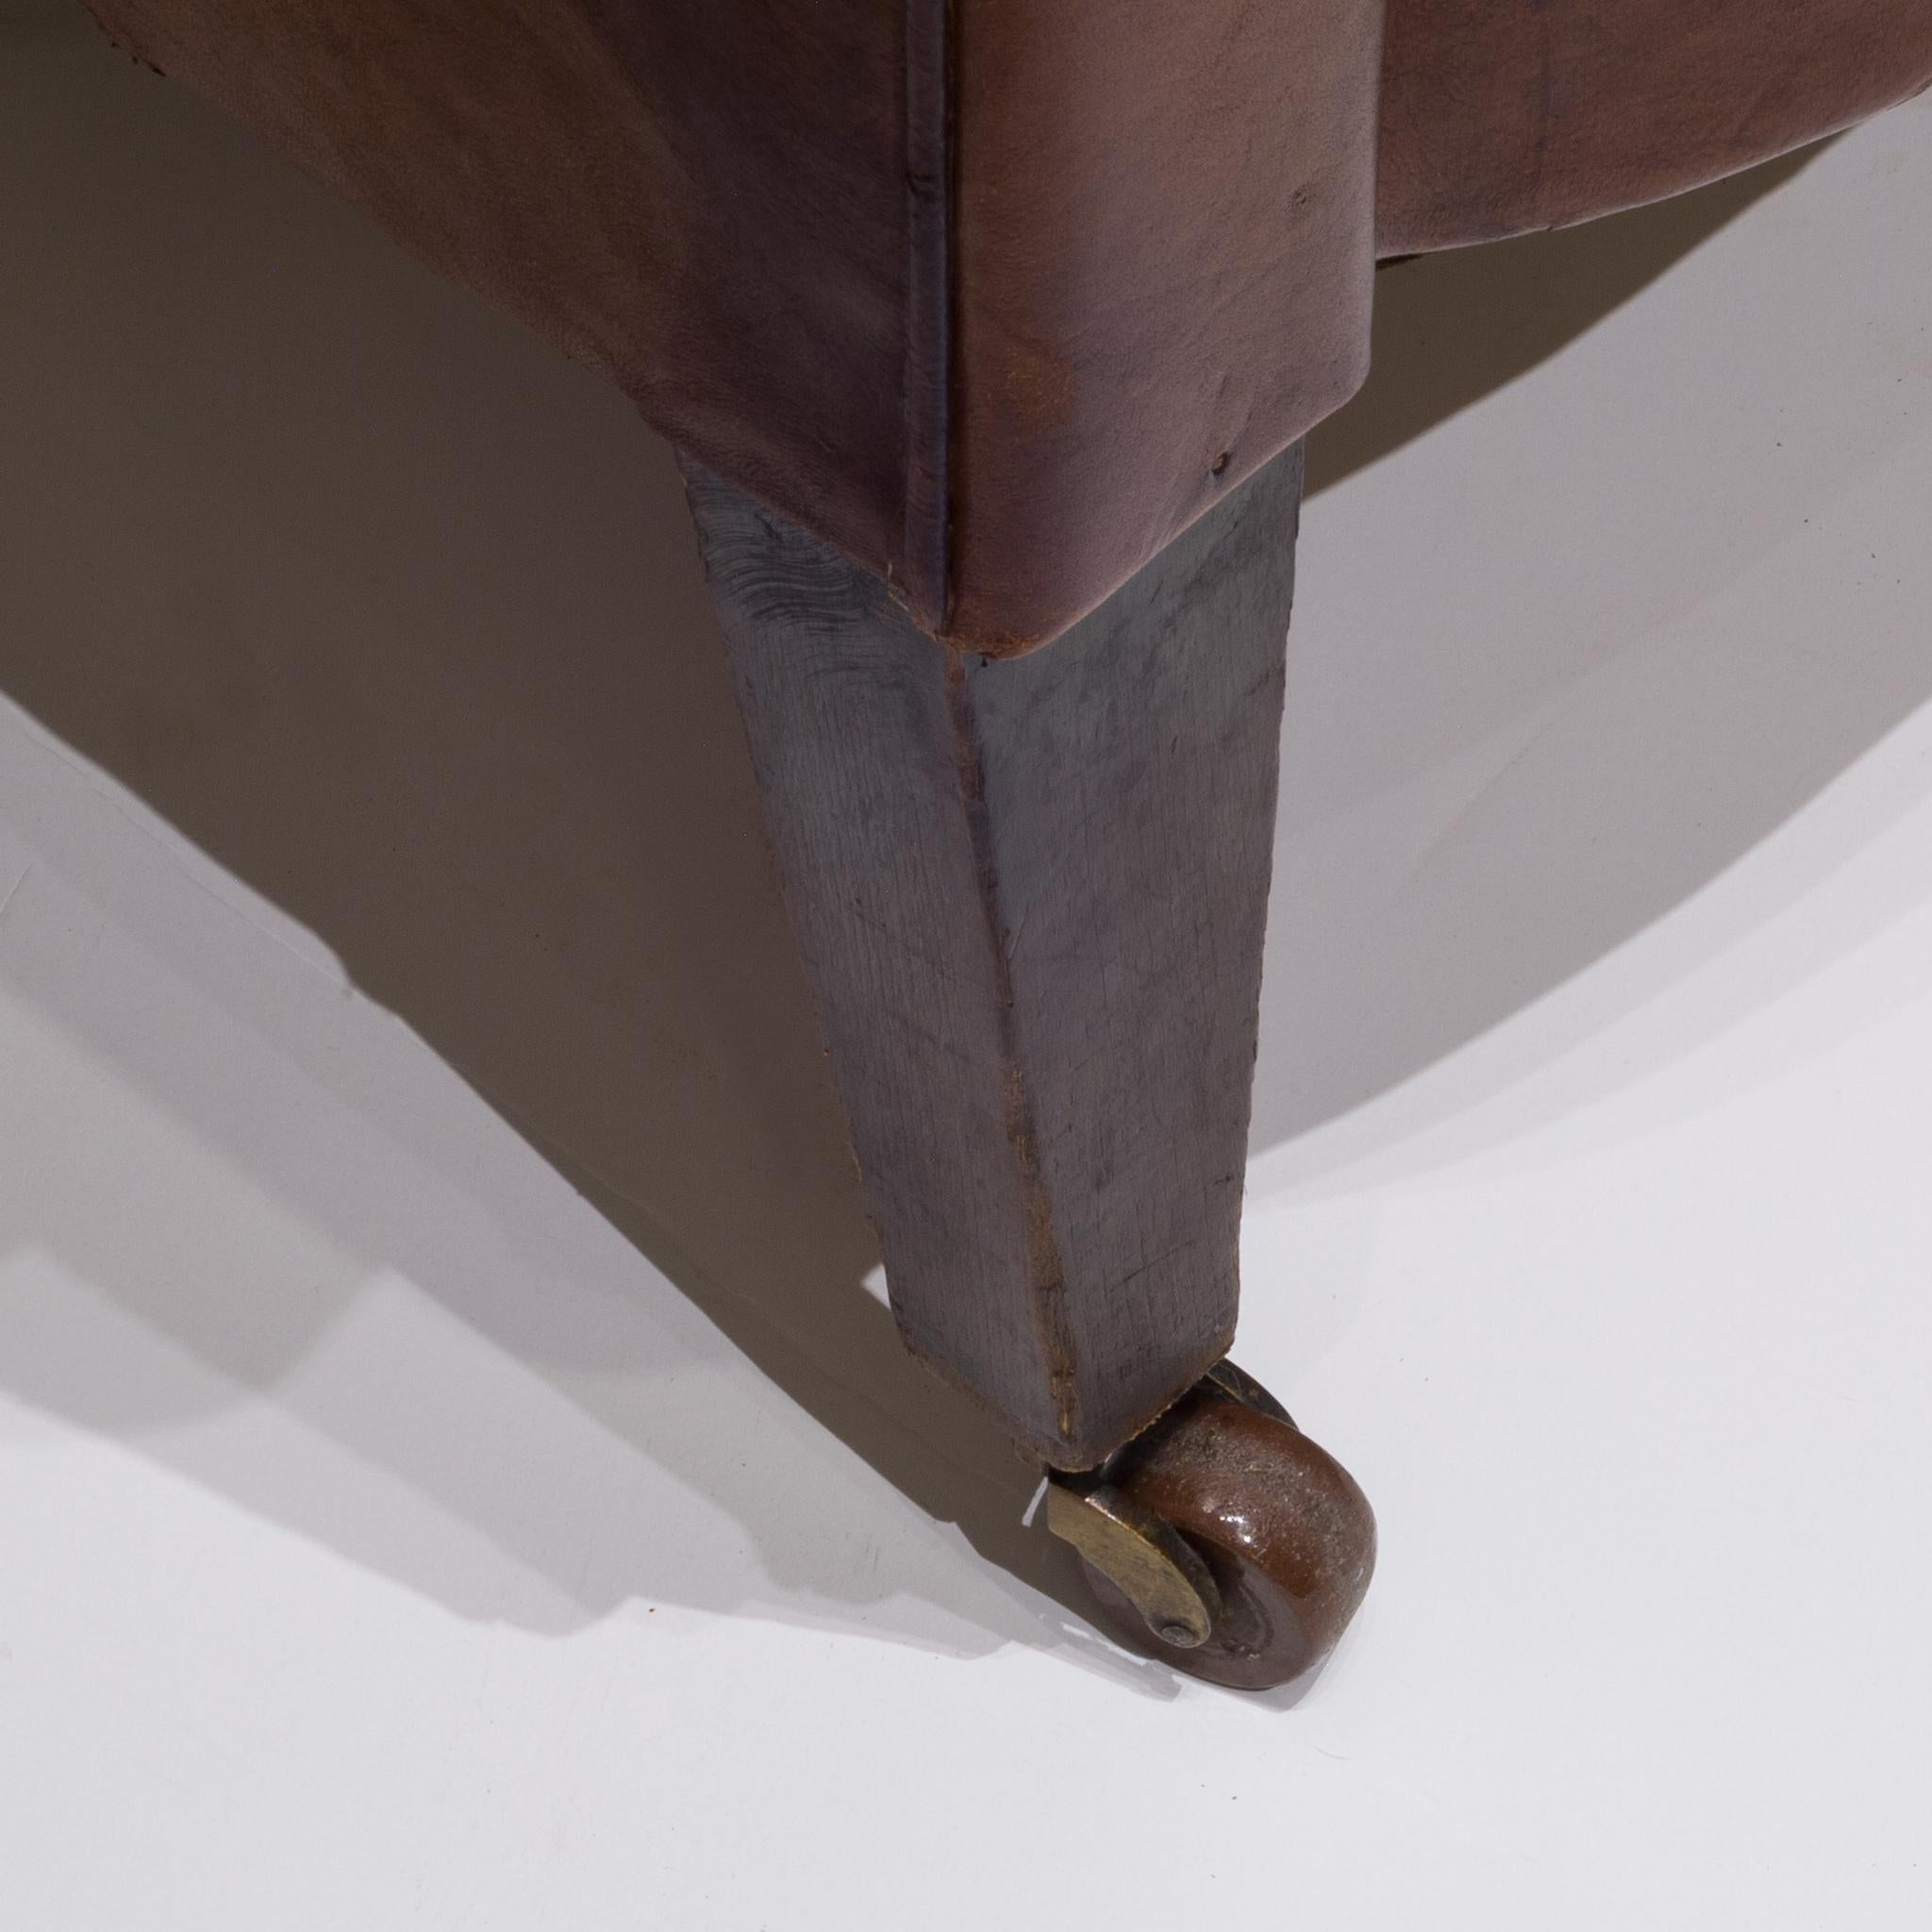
[1377,0,1932,255]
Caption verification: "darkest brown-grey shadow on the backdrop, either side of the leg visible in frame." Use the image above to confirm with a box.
[0,9,1901,1694]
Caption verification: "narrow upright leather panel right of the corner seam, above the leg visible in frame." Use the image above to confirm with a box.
[951,0,1381,651]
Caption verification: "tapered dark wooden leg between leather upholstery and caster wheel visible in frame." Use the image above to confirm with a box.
[686,448,1302,1468]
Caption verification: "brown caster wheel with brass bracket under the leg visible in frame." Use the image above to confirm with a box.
[1047,1362,1375,1690]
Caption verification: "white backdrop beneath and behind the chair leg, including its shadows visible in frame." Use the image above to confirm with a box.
[0,0,1932,1932]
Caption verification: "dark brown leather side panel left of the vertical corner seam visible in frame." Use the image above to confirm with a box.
[87,0,907,610]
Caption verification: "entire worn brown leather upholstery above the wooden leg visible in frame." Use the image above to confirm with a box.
[89,0,1932,655]
